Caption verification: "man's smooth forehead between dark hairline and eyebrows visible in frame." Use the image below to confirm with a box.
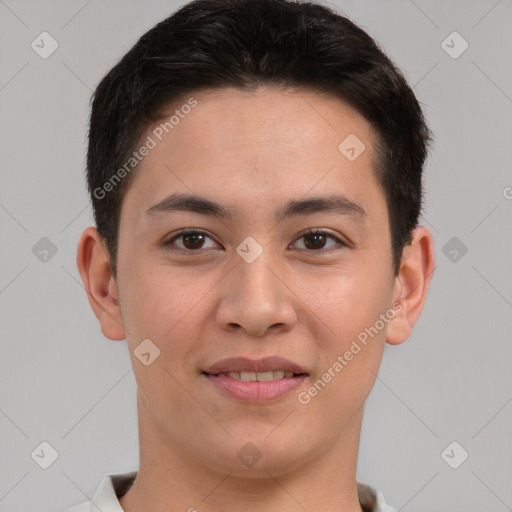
[123,88,383,224]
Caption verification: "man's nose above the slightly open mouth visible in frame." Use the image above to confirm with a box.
[216,246,298,337]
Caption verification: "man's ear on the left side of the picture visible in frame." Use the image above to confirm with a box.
[76,226,126,340]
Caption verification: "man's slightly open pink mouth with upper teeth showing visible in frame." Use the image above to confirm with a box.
[201,357,309,403]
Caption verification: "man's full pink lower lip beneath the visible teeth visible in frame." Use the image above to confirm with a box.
[203,373,307,402]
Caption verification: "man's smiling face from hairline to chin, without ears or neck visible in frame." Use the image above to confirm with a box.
[112,88,396,474]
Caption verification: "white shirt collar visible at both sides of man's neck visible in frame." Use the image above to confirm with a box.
[64,471,396,512]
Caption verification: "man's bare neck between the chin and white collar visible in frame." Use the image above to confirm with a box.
[119,402,363,512]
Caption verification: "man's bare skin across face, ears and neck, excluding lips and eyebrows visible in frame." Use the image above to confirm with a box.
[77,88,434,512]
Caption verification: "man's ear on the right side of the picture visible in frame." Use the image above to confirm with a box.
[386,226,435,345]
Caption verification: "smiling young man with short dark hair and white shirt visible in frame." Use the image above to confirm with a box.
[73,0,434,512]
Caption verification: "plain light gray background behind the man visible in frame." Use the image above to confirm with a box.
[0,0,512,512]
